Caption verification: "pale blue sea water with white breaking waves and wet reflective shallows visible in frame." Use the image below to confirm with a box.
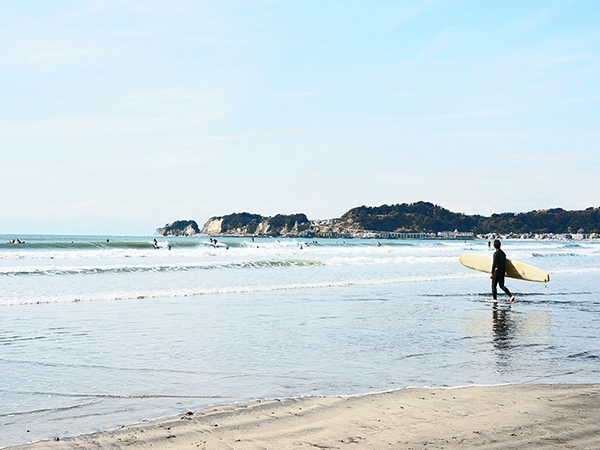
[0,236,600,447]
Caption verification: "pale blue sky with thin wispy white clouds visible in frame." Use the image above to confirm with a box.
[0,0,600,235]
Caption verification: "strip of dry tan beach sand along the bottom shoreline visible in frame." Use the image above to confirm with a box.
[14,384,600,450]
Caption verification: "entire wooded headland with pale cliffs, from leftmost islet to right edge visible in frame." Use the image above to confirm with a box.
[158,202,600,237]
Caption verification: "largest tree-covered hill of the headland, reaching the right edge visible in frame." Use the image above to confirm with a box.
[336,202,600,234]
